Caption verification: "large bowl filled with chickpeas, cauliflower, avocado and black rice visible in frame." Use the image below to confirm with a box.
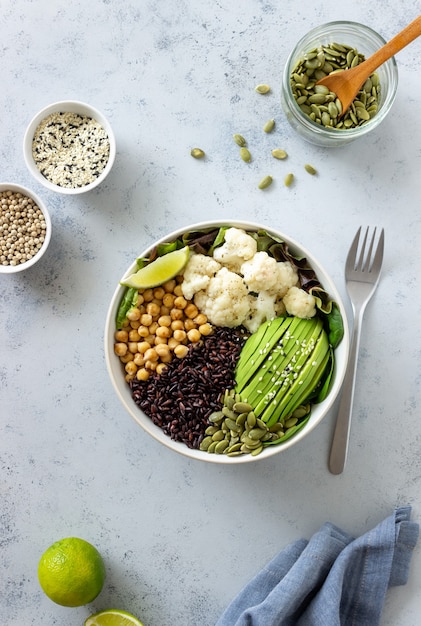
[105,220,349,464]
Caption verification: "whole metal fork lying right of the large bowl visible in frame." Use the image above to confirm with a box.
[329,226,384,474]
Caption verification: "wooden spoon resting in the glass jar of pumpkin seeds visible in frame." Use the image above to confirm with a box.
[316,15,421,115]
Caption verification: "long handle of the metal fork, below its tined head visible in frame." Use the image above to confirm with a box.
[329,308,364,474]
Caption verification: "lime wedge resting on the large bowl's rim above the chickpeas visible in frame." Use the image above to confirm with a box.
[120,246,190,289]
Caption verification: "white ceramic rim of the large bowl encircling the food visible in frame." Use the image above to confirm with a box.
[104,220,349,458]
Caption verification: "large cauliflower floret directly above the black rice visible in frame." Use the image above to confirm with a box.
[194,267,250,328]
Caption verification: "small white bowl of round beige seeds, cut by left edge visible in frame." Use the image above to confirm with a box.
[0,183,51,274]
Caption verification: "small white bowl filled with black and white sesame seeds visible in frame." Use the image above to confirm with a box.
[23,101,116,194]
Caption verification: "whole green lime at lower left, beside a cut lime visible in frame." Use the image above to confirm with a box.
[38,537,105,606]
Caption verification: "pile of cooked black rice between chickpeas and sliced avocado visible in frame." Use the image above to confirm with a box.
[130,328,246,448]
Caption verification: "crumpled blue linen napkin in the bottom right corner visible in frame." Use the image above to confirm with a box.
[216,506,419,626]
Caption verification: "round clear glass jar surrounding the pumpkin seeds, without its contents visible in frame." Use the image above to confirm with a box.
[281,22,398,147]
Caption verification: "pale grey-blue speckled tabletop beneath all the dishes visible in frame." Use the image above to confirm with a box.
[0,0,421,626]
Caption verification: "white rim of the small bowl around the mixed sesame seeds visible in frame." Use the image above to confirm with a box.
[23,100,116,195]
